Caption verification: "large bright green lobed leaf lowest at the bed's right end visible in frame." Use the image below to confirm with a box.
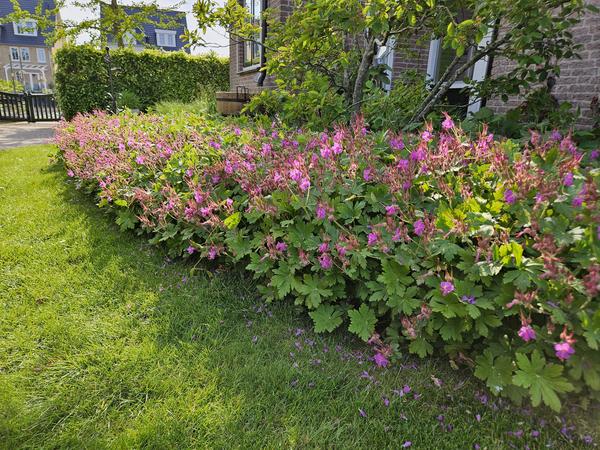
[513,350,575,412]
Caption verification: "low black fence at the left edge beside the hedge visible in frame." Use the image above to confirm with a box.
[0,92,61,122]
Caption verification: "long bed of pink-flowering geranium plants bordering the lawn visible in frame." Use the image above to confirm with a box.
[57,114,600,410]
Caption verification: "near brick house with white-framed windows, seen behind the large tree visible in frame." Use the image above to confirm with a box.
[229,0,600,128]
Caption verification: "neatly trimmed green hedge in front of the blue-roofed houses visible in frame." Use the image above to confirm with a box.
[55,46,229,120]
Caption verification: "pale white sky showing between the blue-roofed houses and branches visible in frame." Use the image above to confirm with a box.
[59,0,229,56]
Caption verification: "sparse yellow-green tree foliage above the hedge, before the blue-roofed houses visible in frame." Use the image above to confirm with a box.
[4,0,182,47]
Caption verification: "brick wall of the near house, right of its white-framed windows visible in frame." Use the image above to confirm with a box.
[486,0,600,128]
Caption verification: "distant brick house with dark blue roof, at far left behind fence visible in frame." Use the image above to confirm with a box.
[0,0,58,92]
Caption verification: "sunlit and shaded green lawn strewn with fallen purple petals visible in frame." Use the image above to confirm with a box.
[0,146,596,449]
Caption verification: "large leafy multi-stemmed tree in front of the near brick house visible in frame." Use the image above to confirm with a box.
[195,0,592,125]
